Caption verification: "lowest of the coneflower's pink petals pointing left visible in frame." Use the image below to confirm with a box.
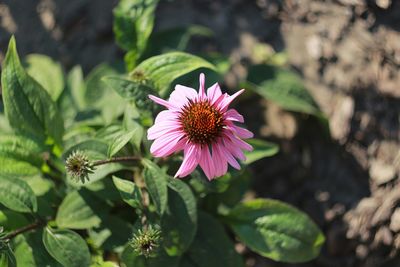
[150,131,186,157]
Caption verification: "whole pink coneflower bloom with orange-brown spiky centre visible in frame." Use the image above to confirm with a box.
[147,74,253,180]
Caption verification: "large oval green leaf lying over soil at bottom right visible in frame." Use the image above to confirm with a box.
[227,199,325,263]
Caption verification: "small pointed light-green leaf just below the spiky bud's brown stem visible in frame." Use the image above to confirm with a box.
[113,176,142,208]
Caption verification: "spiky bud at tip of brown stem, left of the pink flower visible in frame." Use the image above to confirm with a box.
[65,150,94,183]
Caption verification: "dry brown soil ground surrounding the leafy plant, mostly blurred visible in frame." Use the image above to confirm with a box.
[0,0,400,267]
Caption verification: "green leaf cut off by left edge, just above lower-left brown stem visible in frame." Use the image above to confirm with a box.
[0,176,37,212]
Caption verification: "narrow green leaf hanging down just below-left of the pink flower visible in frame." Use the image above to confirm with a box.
[142,159,168,215]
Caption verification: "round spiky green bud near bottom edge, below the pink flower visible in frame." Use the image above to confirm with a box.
[129,225,161,258]
